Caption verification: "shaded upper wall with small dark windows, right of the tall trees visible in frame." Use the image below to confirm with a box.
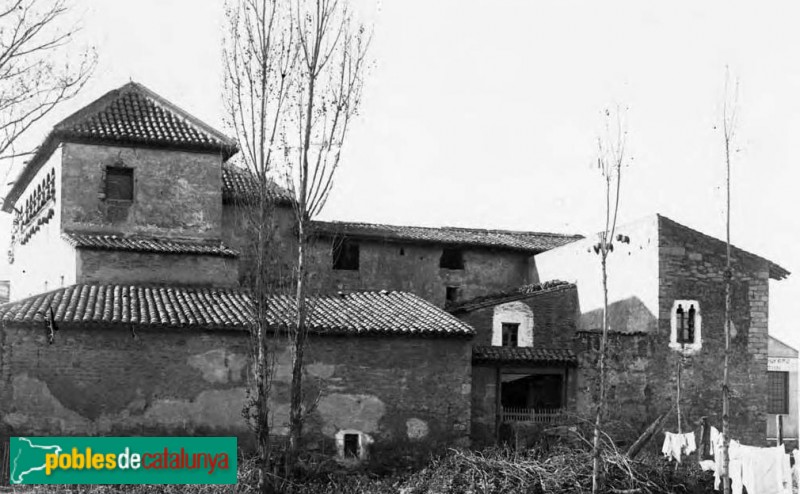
[309,238,535,307]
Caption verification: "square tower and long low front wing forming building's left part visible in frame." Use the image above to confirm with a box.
[0,83,472,456]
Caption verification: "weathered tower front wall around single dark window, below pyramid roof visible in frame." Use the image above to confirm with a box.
[62,143,222,238]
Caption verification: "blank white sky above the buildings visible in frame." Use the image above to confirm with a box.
[0,0,800,347]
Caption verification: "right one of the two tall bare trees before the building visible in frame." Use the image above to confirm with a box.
[288,0,370,466]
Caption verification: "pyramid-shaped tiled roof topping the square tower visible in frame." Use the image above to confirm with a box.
[3,82,237,213]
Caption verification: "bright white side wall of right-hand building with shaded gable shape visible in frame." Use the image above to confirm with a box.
[535,216,659,332]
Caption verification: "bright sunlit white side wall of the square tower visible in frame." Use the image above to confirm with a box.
[9,147,76,301]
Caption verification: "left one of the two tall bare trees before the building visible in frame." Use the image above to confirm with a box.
[223,0,296,492]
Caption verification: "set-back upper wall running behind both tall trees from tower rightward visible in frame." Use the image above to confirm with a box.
[222,204,538,307]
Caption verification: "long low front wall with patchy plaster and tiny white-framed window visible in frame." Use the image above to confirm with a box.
[0,324,471,453]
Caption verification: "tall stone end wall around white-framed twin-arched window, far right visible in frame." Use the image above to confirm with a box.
[659,216,769,444]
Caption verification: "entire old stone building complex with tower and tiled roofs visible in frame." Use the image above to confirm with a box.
[0,83,796,456]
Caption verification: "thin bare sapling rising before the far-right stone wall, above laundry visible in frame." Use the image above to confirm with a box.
[722,69,739,494]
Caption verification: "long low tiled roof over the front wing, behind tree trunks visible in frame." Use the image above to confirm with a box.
[0,284,474,337]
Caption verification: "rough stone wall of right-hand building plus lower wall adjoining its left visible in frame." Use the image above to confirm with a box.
[576,217,769,445]
